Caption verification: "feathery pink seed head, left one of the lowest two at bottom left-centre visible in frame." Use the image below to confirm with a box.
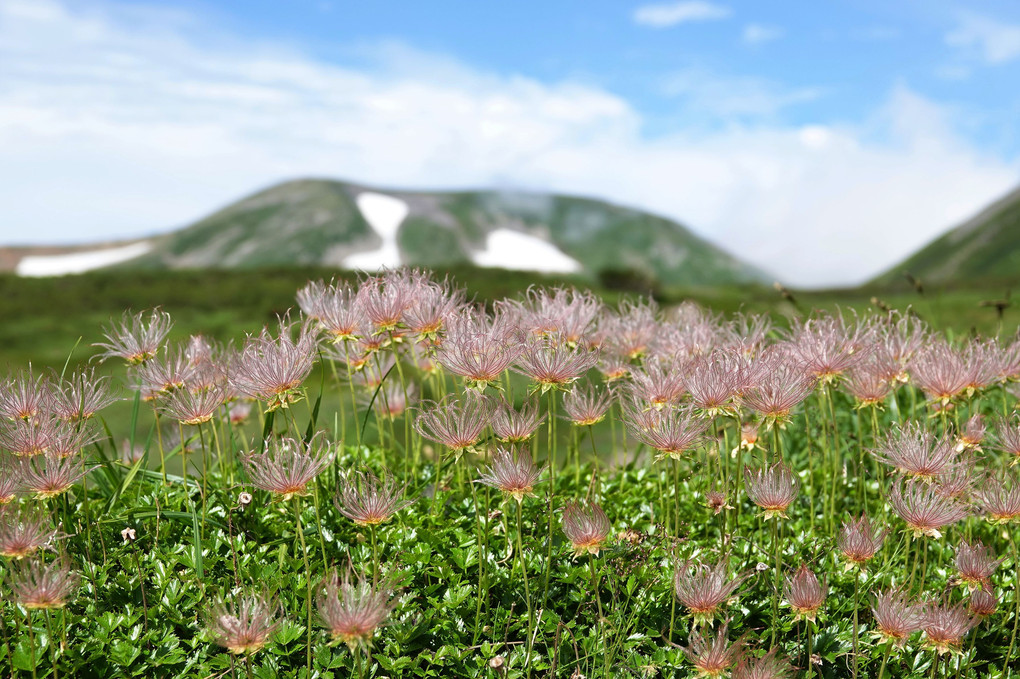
[205,592,282,656]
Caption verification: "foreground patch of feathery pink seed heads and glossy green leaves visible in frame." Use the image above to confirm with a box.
[0,271,1020,677]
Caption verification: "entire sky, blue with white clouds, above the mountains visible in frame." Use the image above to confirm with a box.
[0,0,1020,284]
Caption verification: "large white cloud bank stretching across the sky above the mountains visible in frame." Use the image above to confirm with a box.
[0,0,1020,284]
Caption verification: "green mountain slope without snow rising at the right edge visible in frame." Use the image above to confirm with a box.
[872,182,1020,283]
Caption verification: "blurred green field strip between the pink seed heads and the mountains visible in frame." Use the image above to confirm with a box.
[0,267,1020,372]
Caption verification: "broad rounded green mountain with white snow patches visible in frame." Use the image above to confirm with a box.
[5,179,767,285]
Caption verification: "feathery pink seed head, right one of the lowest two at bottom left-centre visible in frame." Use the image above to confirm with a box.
[315,571,396,652]
